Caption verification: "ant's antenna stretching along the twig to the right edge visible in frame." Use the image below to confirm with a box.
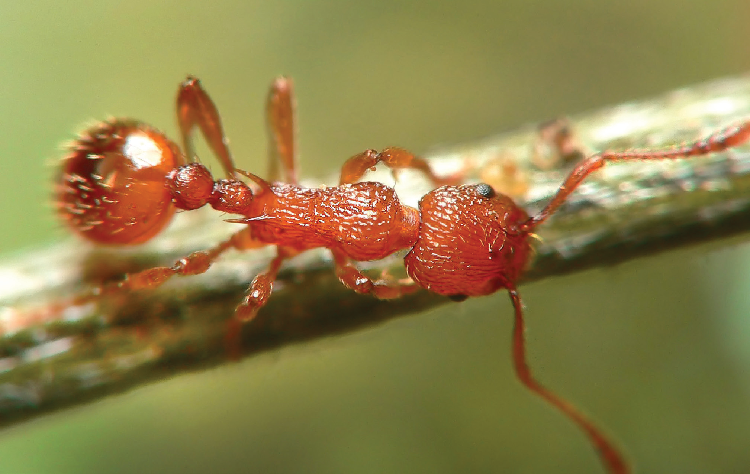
[521,121,750,232]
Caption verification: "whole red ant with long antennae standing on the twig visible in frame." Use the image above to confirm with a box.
[56,77,750,473]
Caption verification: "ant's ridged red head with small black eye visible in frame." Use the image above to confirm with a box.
[405,183,530,297]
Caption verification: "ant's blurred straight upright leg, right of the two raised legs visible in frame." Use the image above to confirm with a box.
[266,77,297,184]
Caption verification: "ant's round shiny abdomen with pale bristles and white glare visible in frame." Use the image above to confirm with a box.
[55,120,184,245]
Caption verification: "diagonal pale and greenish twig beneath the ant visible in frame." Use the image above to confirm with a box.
[0,76,750,425]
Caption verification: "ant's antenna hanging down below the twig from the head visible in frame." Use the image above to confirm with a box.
[508,286,630,474]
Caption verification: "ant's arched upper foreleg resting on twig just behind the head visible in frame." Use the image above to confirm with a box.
[339,147,458,186]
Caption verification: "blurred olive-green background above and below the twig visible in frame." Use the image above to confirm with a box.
[0,0,750,474]
